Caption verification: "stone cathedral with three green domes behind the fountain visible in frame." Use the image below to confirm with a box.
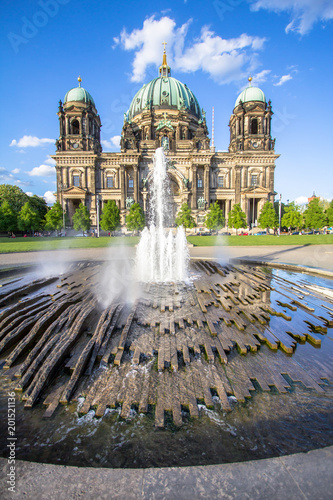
[52,49,279,227]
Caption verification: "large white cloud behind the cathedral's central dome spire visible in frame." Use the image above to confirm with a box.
[114,16,268,83]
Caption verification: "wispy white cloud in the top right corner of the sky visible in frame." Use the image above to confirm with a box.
[250,0,333,35]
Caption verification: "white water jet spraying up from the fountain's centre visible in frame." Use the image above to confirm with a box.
[136,148,190,283]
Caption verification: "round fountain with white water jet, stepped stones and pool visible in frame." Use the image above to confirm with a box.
[0,149,333,467]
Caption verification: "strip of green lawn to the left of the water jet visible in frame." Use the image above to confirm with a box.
[0,236,139,253]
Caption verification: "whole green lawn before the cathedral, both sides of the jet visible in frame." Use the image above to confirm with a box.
[0,234,333,253]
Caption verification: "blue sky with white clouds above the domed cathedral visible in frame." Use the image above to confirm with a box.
[0,0,333,202]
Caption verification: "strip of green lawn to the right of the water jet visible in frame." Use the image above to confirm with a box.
[187,234,333,247]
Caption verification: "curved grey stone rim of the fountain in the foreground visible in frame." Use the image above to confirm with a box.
[0,446,333,500]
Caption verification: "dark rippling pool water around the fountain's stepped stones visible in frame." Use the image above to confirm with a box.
[0,271,333,468]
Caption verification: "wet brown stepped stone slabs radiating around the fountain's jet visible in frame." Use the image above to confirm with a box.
[0,261,333,427]
